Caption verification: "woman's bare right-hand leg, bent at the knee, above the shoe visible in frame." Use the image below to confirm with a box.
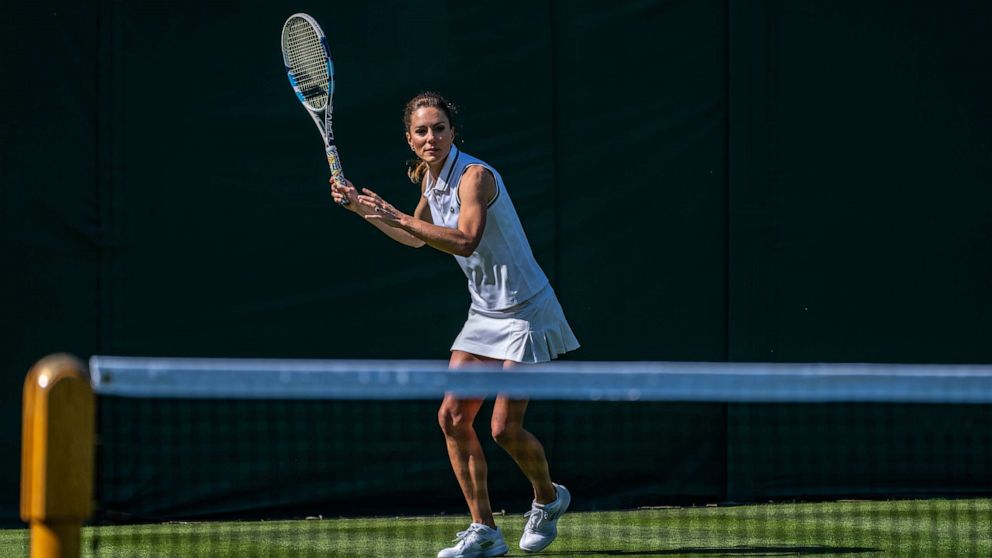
[492,361,557,504]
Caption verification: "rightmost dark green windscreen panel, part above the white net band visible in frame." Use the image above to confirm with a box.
[728,2,992,362]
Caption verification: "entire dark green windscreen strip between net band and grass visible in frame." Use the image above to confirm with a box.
[96,400,992,522]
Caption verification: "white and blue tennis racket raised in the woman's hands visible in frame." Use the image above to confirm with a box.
[282,13,348,205]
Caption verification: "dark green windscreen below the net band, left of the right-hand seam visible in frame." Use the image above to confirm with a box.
[96,400,726,523]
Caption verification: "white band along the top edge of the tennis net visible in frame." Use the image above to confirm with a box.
[90,356,992,403]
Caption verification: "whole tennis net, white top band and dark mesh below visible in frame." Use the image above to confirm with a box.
[84,357,992,557]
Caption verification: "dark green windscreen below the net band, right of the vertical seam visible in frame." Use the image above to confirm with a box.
[726,403,992,502]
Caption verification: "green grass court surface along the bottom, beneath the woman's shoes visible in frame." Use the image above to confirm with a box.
[0,499,992,558]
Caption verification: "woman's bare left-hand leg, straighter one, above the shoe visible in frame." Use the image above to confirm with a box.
[437,351,496,527]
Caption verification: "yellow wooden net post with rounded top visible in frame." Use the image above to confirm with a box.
[21,354,96,558]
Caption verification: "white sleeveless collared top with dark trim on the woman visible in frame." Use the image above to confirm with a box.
[424,146,548,310]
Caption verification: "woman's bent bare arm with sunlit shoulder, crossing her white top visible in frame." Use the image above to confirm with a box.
[358,166,496,257]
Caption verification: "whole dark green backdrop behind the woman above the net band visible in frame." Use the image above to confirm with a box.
[0,0,992,520]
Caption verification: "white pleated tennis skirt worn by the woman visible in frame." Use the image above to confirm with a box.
[451,285,579,363]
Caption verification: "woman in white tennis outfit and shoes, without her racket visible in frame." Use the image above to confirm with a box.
[331,93,579,558]
